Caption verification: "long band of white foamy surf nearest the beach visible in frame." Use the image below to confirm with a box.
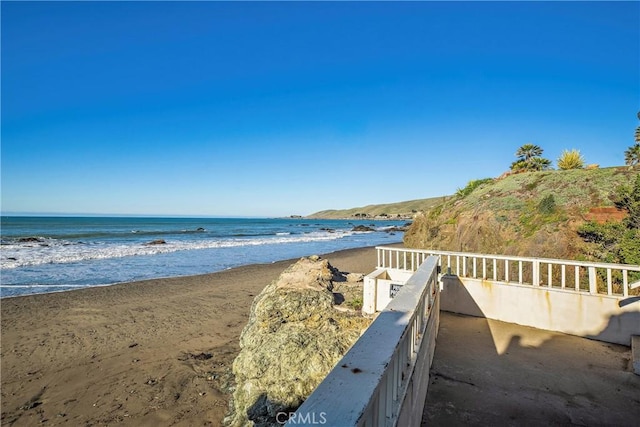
[0,231,354,269]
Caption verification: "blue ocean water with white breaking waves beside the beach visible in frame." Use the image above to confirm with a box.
[0,217,405,297]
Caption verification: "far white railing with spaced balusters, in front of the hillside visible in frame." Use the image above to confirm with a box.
[376,247,640,297]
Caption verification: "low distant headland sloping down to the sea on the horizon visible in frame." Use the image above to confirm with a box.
[307,197,447,219]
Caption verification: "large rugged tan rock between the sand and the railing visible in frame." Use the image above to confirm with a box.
[226,256,370,426]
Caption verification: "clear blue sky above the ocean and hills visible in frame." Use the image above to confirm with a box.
[1,1,640,216]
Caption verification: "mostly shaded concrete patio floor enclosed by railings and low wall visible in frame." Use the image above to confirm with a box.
[422,312,640,427]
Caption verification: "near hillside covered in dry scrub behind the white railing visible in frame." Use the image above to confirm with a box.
[404,167,640,259]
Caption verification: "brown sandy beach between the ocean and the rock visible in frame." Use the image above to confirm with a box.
[1,248,384,426]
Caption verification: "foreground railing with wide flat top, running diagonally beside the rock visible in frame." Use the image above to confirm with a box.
[287,257,439,426]
